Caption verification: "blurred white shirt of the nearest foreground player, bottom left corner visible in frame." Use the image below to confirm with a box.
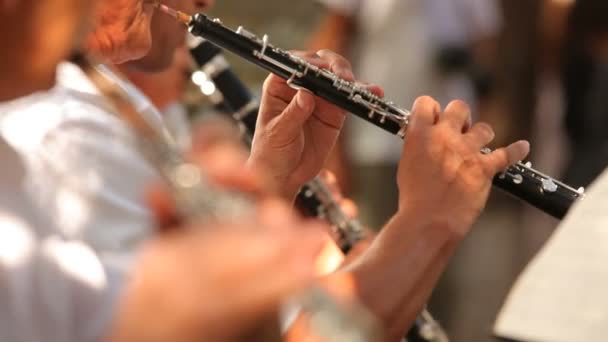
[0,138,124,342]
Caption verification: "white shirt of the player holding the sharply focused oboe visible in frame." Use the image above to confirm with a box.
[0,63,162,265]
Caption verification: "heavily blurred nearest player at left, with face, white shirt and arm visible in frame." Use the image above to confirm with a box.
[0,0,332,342]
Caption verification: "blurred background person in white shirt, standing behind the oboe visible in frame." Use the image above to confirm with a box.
[310,0,502,227]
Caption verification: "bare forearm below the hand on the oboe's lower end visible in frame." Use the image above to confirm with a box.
[345,214,460,341]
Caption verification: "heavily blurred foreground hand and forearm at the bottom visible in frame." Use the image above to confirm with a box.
[109,202,324,342]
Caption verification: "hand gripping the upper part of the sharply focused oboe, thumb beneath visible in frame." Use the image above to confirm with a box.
[250,50,382,200]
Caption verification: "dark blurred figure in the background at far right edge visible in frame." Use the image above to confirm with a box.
[563,0,608,185]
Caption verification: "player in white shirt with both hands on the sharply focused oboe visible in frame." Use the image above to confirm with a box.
[3,0,528,339]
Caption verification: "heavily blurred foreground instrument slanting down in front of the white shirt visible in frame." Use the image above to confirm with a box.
[74,56,254,221]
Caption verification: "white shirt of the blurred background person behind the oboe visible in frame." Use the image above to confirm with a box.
[318,0,500,164]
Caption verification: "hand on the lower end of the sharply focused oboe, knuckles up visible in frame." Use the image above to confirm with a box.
[397,97,529,236]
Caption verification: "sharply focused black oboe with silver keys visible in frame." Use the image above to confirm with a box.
[177,12,584,219]
